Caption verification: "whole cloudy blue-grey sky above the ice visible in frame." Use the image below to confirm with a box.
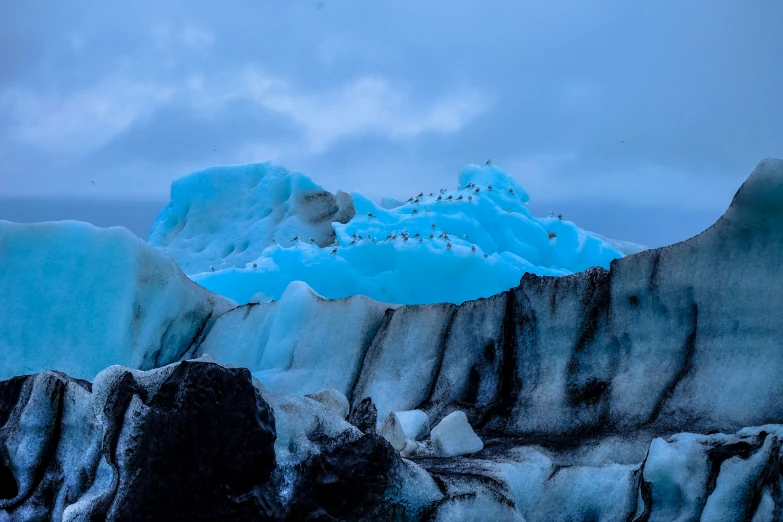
[0,0,783,246]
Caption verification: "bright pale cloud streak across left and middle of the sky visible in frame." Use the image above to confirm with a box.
[0,66,489,158]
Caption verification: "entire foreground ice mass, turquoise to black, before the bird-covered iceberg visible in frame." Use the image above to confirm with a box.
[0,160,783,522]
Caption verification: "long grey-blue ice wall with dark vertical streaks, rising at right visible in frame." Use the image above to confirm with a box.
[202,160,783,437]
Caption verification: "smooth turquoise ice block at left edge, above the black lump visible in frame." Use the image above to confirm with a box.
[0,221,235,379]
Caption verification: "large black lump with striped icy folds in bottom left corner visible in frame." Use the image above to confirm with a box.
[0,362,275,521]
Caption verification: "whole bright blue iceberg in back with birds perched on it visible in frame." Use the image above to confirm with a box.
[149,160,622,304]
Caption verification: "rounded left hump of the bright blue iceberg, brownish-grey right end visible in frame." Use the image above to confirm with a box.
[148,163,354,274]
